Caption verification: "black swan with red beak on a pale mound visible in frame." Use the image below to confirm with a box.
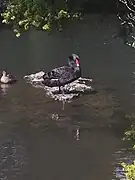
[43,54,81,91]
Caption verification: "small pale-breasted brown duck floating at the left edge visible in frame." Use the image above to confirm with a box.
[0,70,16,84]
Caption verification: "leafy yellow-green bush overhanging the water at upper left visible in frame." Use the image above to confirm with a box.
[1,0,80,37]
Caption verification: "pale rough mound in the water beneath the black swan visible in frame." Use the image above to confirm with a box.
[24,71,96,102]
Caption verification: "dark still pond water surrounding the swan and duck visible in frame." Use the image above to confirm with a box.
[0,15,135,180]
